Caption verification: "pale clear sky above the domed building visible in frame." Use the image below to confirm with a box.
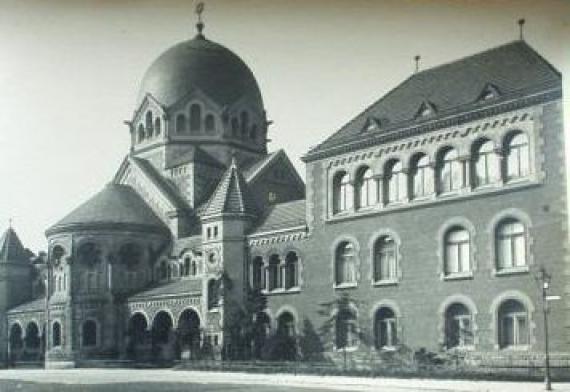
[0,0,570,252]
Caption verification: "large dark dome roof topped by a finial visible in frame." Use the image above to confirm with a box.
[138,34,263,111]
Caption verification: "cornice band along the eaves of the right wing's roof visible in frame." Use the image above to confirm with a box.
[301,86,562,163]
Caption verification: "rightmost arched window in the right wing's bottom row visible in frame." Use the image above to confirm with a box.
[498,299,529,348]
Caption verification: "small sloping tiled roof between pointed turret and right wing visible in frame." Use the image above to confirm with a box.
[254,200,307,233]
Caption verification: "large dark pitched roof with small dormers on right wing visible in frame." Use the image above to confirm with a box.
[306,41,561,159]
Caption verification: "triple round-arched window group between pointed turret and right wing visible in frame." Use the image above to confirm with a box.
[250,251,300,292]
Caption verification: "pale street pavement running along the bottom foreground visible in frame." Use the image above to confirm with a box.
[0,369,570,392]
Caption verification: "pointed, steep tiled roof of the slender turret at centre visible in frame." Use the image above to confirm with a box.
[204,159,255,216]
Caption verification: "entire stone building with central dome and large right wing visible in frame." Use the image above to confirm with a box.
[0,28,570,365]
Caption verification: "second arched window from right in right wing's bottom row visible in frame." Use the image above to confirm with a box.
[445,303,473,349]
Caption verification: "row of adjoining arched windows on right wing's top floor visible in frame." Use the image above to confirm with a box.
[332,131,531,214]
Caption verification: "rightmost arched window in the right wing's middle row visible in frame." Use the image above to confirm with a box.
[495,219,527,270]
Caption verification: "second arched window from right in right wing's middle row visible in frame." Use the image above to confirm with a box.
[444,227,471,275]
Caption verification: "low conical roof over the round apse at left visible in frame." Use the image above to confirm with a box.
[46,184,168,235]
